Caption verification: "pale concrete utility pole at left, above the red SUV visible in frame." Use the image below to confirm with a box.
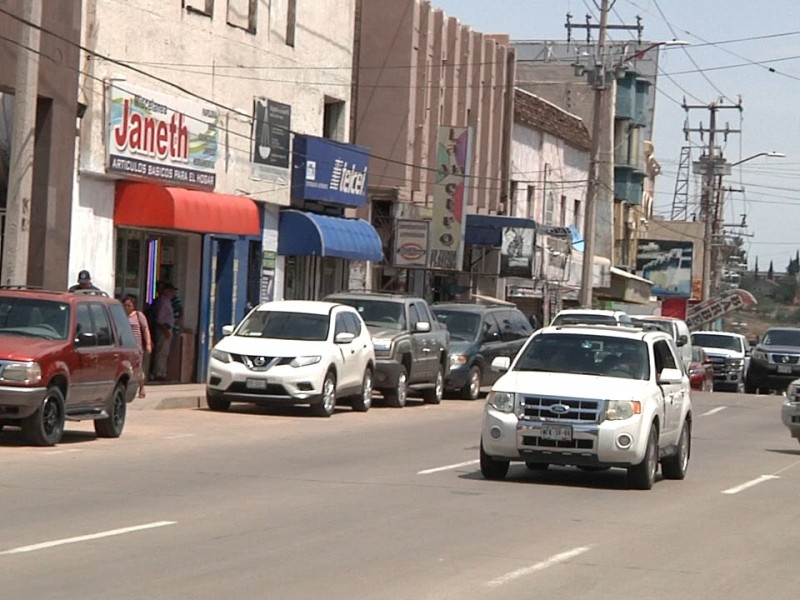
[0,0,42,285]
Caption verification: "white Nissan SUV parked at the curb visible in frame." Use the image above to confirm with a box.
[206,300,375,417]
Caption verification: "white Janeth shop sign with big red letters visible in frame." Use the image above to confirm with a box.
[106,83,219,189]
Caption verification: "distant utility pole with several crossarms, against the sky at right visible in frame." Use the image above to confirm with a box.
[683,100,742,300]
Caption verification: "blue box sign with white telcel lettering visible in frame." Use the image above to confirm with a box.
[292,135,369,207]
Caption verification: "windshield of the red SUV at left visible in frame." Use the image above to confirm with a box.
[0,297,69,340]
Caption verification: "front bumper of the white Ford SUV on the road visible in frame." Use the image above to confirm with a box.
[481,408,648,467]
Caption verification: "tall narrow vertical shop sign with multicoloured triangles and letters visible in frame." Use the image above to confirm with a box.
[428,127,472,271]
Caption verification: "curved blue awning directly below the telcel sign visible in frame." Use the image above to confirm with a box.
[278,210,383,261]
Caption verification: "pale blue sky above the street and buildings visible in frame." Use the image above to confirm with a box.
[431,0,800,271]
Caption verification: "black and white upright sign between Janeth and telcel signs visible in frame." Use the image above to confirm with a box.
[250,98,292,183]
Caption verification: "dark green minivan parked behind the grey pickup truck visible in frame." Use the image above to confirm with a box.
[431,304,533,400]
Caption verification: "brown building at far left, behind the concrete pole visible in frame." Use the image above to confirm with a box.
[0,0,81,289]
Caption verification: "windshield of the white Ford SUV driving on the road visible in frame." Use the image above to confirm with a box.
[514,333,650,380]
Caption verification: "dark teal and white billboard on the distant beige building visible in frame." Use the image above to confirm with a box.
[636,240,694,298]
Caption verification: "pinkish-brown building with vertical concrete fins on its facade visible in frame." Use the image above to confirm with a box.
[353,0,514,300]
